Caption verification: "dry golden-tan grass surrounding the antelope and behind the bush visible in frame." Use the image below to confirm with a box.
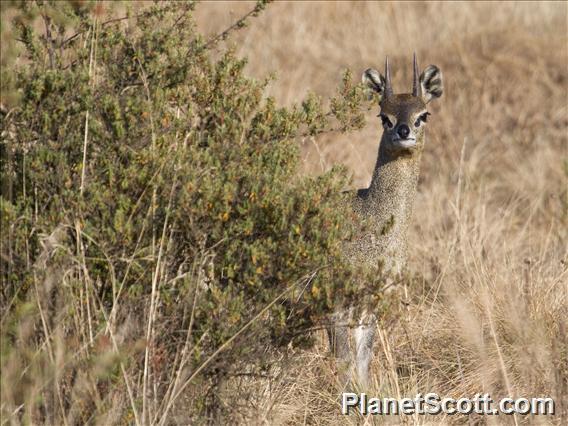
[192,2,568,424]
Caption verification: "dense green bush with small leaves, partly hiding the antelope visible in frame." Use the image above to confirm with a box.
[1,2,384,423]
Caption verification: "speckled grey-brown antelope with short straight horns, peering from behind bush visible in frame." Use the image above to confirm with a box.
[329,55,443,387]
